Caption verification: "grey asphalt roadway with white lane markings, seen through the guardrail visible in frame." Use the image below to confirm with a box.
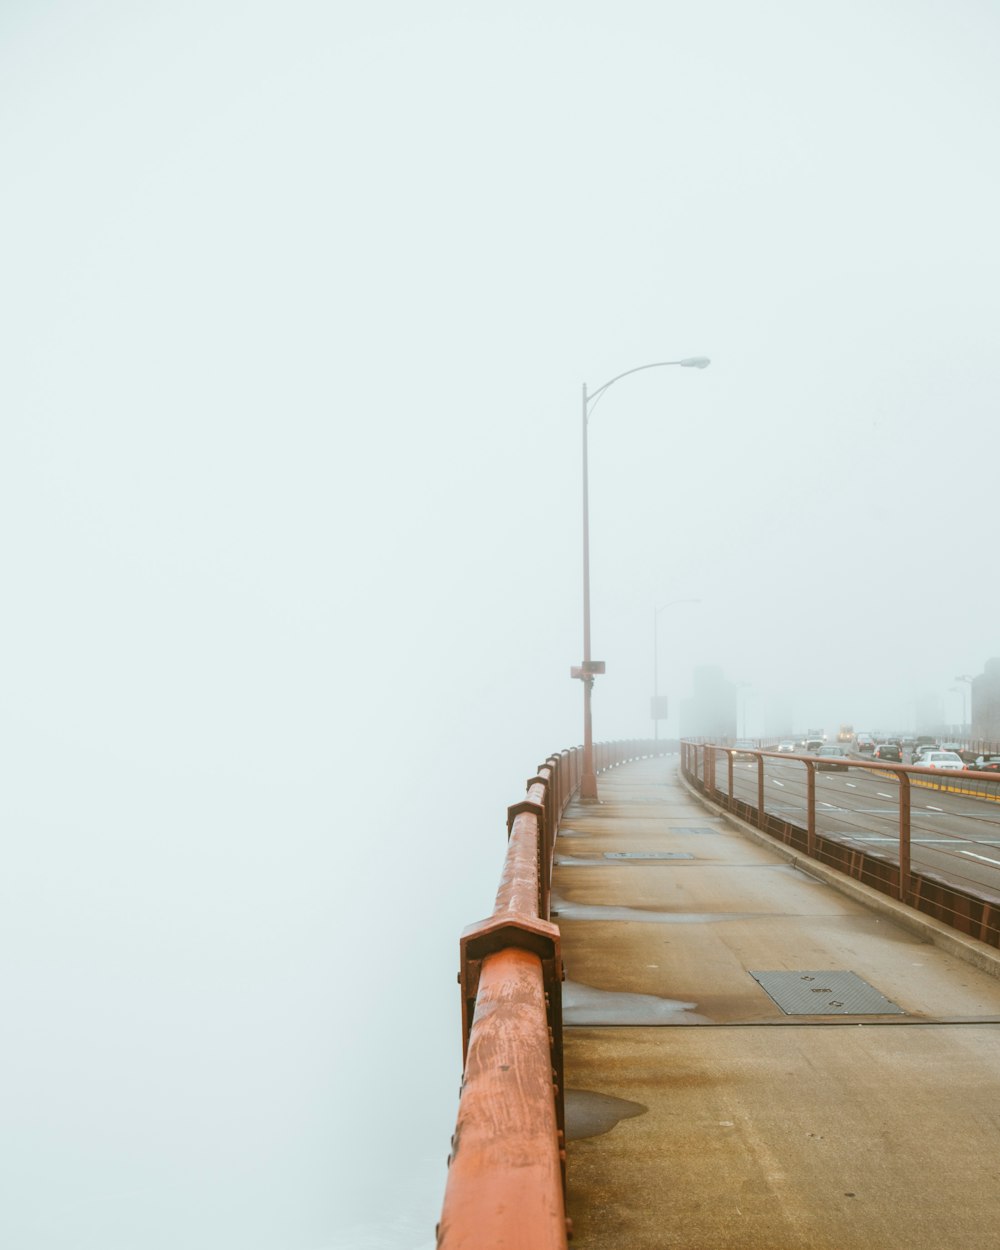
[716,756,1000,898]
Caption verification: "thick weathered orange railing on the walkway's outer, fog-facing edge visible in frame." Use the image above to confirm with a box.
[438,740,665,1250]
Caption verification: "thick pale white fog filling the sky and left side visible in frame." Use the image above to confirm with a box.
[0,0,1000,1250]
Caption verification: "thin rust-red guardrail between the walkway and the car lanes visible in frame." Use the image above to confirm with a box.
[681,741,1000,946]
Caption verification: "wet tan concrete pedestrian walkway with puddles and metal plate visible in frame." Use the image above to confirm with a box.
[553,760,1000,1250]
